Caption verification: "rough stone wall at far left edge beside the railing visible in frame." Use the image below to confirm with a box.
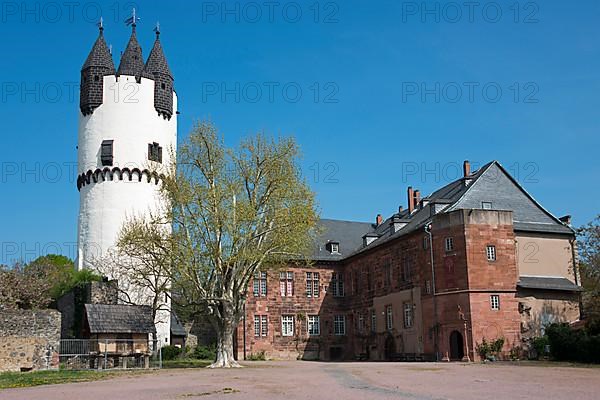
[0,310,61,372]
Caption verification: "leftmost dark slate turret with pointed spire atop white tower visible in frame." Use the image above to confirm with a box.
[79,19,115,115]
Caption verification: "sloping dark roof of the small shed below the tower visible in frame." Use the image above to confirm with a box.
[85,304,156,334]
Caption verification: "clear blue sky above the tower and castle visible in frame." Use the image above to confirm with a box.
[0,0,600,263]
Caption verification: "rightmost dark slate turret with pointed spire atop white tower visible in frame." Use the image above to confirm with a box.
[144,24,173,119]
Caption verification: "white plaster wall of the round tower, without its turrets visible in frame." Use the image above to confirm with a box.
[77,75,177,344]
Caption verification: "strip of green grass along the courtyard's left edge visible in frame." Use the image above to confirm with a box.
[0,370,149,389]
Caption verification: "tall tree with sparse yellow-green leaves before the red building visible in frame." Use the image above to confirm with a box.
[122,122,318,368]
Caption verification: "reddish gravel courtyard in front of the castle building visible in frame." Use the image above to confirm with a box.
[0,361,600,400]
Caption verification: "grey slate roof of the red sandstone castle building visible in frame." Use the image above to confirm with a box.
[316,161,574,260]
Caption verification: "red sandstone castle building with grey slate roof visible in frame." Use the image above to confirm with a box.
[237,161,581,360]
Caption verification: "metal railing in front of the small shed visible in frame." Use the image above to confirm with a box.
[59,339,162,370]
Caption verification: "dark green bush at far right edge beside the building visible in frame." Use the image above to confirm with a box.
[546,324,600,363]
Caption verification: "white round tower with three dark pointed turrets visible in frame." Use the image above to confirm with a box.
[77,20,177,345]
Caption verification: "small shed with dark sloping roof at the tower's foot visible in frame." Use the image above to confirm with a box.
[84,304,156,355]
